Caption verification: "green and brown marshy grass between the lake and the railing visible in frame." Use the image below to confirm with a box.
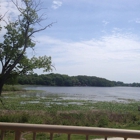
[0,85,140,140]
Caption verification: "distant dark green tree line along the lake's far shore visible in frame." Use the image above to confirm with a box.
[17,73,140,87]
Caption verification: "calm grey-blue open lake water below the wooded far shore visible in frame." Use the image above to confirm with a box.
[26,86,140,102]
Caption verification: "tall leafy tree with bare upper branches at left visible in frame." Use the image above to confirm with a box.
[0,0,53,95]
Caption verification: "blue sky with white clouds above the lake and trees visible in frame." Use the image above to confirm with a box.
[0,0,140,83]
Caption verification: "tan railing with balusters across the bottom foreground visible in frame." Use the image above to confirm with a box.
[0,122,140,140]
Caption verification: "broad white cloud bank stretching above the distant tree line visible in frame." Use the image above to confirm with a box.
[32,34,140,82]
